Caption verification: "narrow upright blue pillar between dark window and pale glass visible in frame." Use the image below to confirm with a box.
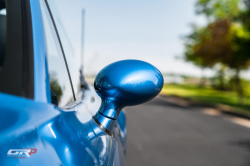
[30,0,51,103]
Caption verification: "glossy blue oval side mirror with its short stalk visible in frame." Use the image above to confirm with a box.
[93,60,164,135]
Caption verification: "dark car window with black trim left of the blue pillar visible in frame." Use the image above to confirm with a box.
[0,0,34,99]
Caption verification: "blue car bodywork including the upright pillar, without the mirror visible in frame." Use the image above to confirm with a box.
[0,0,126,166]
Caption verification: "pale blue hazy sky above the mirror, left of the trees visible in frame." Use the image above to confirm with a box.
[52,0,213,76]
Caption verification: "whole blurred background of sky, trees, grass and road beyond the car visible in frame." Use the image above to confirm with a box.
[52,0,250,166]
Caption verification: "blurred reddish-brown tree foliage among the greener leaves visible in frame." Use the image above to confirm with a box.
[185,19,233,67]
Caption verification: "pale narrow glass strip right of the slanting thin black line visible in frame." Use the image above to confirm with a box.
[42,0,81,97]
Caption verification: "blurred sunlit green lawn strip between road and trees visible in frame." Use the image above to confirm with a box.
[161,84,250,113]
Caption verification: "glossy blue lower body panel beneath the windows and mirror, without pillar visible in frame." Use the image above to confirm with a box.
[0,94,125,165]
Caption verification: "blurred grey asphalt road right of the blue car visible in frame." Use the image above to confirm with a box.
[126,98,250,166]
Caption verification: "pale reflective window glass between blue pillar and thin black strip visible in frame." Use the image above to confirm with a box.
[40,0,74,107]
